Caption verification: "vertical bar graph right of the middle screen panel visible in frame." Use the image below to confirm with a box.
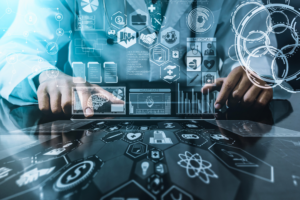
[177,83,217,115]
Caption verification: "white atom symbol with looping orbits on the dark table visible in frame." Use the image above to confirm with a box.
[177,151,219,184]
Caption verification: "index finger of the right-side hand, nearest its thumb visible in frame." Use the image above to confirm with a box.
[215,68,244,109]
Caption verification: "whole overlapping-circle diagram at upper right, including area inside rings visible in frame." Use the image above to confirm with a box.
[233,0,300,93]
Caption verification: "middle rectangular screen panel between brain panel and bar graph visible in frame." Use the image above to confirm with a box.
[129,89,171,115]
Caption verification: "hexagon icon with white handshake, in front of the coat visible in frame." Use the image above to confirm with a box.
[139,26,158,48]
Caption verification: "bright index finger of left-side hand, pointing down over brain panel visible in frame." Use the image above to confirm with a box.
[76,88,94,117]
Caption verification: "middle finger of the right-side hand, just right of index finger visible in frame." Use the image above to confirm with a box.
[227,76,252,107]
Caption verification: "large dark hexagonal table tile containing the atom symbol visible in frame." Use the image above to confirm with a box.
[164,143,240,200]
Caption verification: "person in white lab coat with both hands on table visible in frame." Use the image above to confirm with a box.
[0,0,288,117]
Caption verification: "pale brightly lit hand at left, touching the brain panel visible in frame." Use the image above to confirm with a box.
[37,71,124,117]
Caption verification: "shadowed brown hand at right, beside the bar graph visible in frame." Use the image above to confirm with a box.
[201,67,273,109]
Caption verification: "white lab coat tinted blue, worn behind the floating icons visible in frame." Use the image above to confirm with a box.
[0,0,289,105]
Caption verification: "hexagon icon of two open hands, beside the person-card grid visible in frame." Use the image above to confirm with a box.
[160,64,180,84]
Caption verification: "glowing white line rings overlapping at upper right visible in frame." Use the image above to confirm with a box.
[230,1,300,92]
